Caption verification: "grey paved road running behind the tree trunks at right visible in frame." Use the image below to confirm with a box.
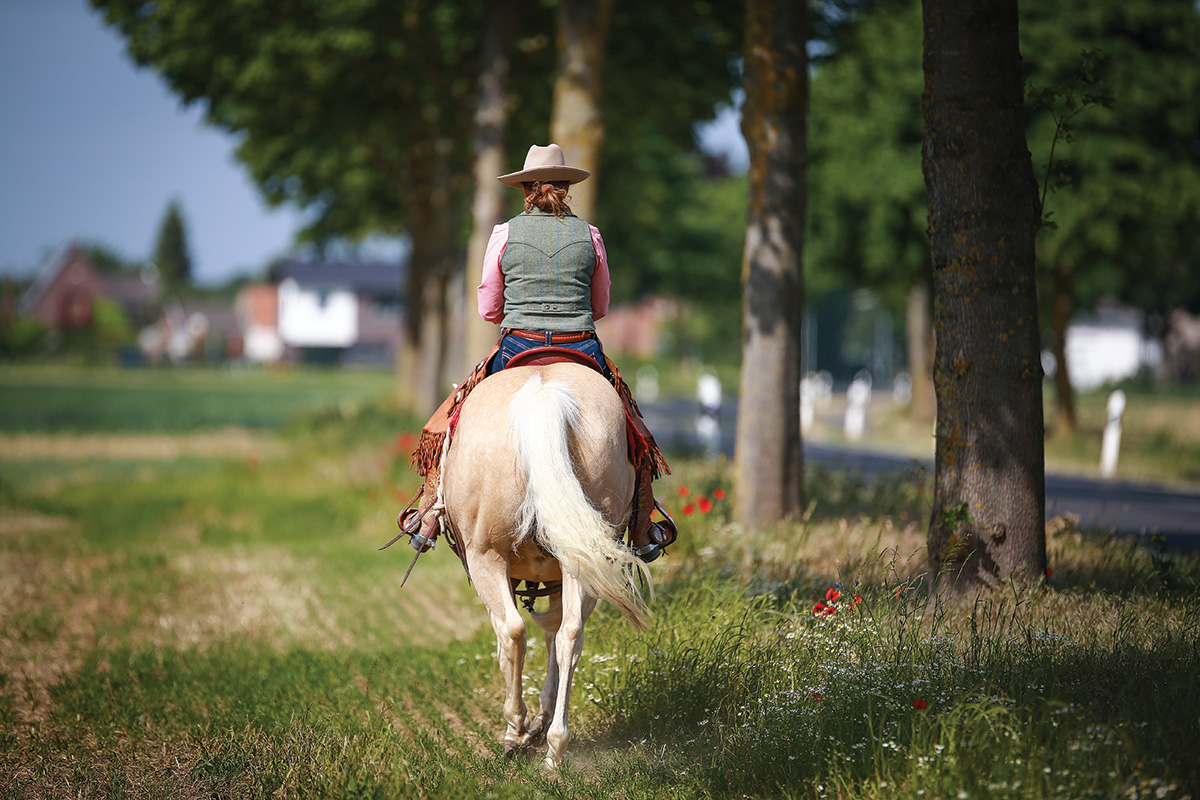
[642,399,1200,549]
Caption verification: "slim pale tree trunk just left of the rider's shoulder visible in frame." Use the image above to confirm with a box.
[462,0,515,374]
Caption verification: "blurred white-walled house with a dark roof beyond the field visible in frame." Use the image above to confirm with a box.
[276,260,408,365]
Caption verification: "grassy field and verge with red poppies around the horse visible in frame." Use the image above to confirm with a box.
[0,368,1200,800]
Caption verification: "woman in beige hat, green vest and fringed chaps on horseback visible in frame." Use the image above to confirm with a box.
[397,144,676,561]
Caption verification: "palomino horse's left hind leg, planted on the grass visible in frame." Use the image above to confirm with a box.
[468,553,529,758]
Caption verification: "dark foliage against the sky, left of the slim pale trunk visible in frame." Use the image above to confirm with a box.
[92,0,492,240]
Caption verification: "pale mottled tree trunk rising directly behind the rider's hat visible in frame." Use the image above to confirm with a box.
[550,0,613,221]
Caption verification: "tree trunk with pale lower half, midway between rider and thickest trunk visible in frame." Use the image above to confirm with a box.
[734,0,808,528]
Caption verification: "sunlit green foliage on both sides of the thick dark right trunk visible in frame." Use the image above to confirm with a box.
[805,0,1200,316]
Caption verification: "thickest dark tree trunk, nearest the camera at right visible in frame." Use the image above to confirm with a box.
[922,0,1045,593]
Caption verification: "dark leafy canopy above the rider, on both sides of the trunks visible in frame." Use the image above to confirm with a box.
[91,0,742,269]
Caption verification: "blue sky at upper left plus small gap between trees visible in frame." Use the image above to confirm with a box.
[0,0,744,284]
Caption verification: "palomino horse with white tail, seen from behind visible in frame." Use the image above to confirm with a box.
[443,363,649,768]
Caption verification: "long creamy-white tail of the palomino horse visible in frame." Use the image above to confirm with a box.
[509,373,653,628]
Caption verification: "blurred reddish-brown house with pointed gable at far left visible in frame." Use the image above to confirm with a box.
[18,243,161,331]
